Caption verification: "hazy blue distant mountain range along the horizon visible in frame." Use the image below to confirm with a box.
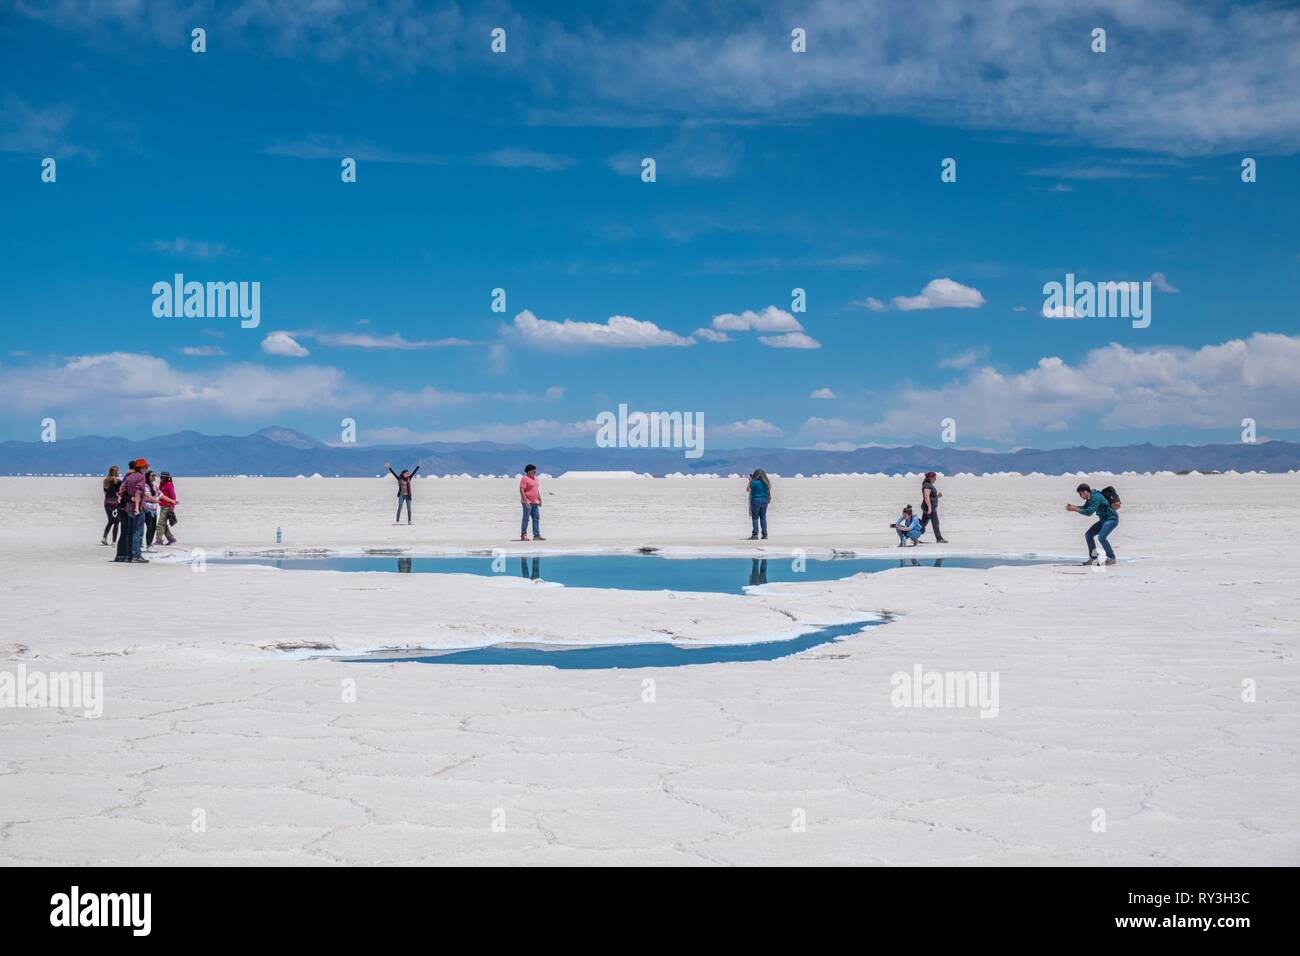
[0,427,1300,477]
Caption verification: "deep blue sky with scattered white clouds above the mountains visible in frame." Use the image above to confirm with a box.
[0,0,1300,449]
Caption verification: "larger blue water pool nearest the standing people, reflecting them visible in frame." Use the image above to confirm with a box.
[208,554,1058,594]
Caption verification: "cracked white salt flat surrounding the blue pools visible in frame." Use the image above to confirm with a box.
[0,475,1300,865]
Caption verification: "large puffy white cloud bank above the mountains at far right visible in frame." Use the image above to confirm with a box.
[868,332,1300,441]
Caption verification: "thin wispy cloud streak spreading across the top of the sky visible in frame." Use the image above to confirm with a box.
[25,0,1300,153]
